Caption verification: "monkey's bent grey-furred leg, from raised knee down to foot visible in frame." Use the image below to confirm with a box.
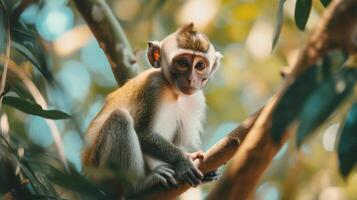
[94,109,176,195]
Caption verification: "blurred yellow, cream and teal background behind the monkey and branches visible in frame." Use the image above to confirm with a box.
[0,0,357,200]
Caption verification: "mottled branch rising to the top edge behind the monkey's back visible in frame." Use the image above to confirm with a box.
[73,0,137,85]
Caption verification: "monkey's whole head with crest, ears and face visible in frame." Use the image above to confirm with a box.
[147,23,223,95]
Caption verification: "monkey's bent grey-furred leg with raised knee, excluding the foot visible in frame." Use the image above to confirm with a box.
[94,109,145,179]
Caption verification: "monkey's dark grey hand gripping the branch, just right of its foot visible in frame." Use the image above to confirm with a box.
[175,154,203,187]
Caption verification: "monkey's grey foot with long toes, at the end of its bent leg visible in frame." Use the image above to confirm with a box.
[152,165,178,188]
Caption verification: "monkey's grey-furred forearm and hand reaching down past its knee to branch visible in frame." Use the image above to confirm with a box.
[138,132,203,186]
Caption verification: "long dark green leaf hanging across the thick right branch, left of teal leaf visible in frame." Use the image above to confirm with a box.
[272,50,348,143]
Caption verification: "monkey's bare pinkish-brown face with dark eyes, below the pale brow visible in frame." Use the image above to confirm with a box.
[166,53,211,95]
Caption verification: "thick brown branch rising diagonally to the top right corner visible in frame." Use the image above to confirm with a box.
[208,0,357,199]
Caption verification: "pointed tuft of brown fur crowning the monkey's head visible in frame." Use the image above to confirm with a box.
[177,23,209,53]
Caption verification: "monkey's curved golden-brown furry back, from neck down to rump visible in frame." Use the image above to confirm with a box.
[82,69,169,166]
